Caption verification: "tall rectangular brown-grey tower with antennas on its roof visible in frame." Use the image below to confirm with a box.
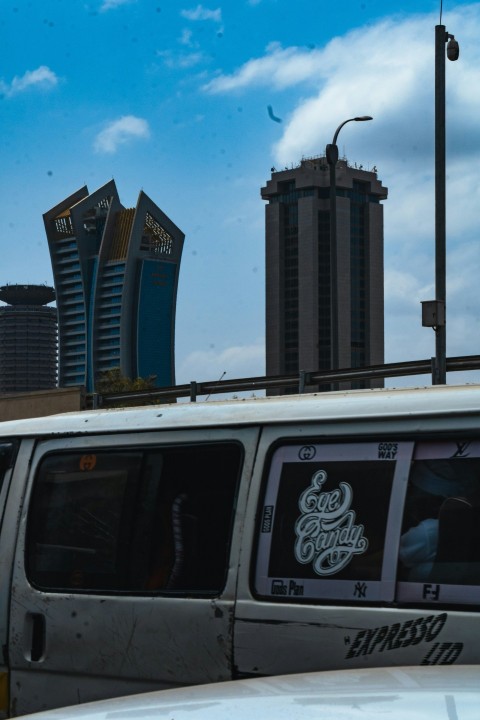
[261,157,388,386]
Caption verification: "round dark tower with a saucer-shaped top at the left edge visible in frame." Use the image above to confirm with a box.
[0,285,57,394]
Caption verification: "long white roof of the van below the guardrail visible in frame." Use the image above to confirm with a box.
[0,385,480,439]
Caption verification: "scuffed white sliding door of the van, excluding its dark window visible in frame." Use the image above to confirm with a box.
[9,428,258,714]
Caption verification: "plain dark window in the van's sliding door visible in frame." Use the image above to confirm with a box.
[26,443,242,595]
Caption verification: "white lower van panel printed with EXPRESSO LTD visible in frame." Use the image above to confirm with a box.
[235,603,480,678]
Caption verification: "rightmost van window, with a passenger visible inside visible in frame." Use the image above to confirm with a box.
[398,441,480,602]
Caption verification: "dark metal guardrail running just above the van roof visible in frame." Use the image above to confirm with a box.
[92,355,480,408]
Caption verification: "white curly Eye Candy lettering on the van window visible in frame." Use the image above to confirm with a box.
[294,470,368,576]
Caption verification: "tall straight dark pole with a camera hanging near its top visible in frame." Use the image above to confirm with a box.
[432,25,460,385]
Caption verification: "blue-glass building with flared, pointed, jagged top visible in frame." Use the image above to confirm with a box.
[43,180,184,392]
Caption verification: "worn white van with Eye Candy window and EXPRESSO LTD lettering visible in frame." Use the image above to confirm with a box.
[0,385,480,716]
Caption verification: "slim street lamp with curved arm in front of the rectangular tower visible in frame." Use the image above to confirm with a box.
[325,115,373,370]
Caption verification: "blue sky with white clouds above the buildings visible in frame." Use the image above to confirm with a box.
[0,0,480,394]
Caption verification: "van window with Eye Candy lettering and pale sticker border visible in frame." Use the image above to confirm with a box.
[255,442,410,601]
